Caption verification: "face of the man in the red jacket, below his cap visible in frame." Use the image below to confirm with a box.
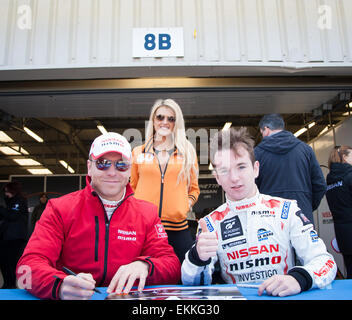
[87,152,131,201]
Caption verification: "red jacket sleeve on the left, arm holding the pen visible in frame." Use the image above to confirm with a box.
[16,201,66,299]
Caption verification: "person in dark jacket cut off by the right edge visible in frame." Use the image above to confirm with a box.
[326,146,352,279]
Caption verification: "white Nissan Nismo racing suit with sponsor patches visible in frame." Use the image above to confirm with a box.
[182,192,337,291]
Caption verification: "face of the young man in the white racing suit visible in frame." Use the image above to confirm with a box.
[214,147,259,201]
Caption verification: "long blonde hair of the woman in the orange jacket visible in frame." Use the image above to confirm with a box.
[145,99,198,186]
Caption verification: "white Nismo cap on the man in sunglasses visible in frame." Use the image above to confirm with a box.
[89,132,132,160]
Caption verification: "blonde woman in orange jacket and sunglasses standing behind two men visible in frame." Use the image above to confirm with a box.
[131,99,199,263]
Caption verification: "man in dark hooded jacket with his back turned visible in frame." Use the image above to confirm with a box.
[254,114,326,224]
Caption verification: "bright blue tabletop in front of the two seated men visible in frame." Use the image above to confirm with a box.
[0,279,352,301]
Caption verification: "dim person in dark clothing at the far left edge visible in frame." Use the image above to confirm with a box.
[0,182,28,289]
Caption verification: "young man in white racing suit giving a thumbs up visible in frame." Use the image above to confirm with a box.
[182,128,337,296]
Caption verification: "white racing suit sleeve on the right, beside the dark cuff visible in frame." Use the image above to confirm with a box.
[289,201,337,288]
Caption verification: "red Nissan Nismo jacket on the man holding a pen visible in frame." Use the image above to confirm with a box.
[17,177,181,299]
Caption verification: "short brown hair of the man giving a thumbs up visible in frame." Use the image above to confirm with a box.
[210,127,255,168]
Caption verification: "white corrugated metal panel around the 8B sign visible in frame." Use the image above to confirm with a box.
[0,0,352,69]
